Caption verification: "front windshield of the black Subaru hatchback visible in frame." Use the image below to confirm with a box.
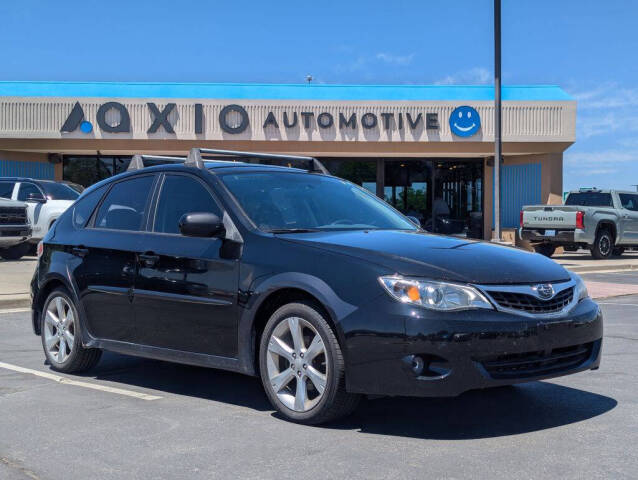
[221,172,416,232]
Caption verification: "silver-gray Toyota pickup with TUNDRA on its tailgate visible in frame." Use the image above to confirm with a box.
[519,189,638,259]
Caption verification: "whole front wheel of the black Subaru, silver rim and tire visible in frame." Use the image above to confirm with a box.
[259,302,359,424]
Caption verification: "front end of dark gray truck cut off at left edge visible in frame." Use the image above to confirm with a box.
[0,198,31,260]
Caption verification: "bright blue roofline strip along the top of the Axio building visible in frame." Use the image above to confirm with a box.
[0,81,574,101]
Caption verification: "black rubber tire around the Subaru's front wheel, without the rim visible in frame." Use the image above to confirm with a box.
[259,301,360,425]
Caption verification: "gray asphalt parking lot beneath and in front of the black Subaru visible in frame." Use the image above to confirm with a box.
[0,295,638,479]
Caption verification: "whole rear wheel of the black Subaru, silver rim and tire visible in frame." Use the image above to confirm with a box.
[40,288,102,373]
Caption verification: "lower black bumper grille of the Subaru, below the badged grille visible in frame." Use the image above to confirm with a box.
[480,342,594,380]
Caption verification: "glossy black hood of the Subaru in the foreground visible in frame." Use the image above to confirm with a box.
[280,230,570,284]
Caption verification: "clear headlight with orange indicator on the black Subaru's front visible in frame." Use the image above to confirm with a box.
[379,276,493,311]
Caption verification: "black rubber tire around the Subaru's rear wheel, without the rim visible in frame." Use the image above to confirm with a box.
[40,287,102,373]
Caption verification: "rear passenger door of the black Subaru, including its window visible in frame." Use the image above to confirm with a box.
[72,174,156,342]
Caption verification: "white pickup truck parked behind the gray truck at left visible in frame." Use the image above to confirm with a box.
[0,177,81,248]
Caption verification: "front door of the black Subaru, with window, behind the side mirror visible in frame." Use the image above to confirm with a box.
[133,173,239,358]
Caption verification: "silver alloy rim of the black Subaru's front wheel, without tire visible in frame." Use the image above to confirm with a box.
[266,317,328,412]
